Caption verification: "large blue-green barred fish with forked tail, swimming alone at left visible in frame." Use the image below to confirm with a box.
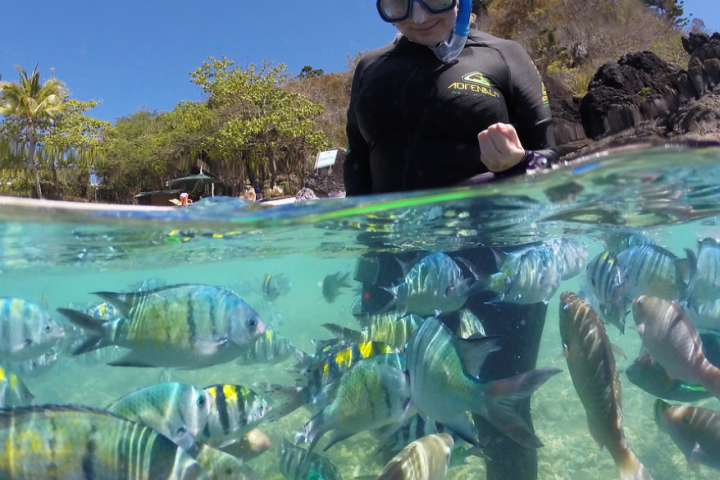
[59,284,265,368]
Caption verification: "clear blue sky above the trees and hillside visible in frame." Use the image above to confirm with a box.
[0,0,720,121]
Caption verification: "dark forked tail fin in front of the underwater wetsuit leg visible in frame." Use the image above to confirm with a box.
[475,367,562,448]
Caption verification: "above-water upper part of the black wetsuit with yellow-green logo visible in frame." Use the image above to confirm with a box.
[344,30,558,195]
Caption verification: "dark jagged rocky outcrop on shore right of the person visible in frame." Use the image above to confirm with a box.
[547,33,720,159]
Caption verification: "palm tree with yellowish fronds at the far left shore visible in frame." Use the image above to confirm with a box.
[0,65,68,198]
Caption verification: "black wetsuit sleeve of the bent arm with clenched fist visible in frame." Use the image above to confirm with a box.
[503,42,559,169]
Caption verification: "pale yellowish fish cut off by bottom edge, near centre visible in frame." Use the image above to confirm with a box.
[377,433,454,480]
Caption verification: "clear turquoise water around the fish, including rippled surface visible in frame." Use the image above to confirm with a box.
[0,146,720,480]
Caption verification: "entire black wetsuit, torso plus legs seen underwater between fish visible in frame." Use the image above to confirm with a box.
[344,30,558,480]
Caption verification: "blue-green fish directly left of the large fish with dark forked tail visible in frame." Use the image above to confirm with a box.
[295,354,415,451]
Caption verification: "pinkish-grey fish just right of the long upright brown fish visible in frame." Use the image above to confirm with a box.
[633,295,720,398]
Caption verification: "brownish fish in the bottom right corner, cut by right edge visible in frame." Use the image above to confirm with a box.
[655,399,720,470]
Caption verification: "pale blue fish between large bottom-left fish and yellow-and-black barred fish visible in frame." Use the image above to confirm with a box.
[106,383,212,453]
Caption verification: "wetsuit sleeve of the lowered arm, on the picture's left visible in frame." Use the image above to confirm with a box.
[343,62,372,196]
